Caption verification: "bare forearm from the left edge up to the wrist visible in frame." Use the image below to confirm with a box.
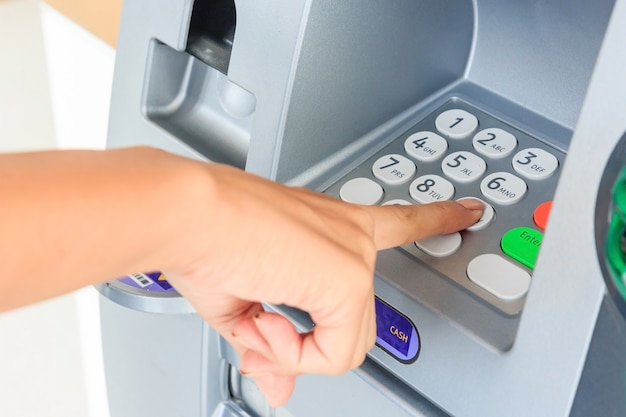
[0,148,212,311]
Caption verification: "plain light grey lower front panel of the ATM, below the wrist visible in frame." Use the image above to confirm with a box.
[100,297,204,417]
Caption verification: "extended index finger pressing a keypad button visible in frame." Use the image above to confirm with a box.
[363,199,484,249]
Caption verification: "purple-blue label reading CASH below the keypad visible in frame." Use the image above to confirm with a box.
[375,297,420,363]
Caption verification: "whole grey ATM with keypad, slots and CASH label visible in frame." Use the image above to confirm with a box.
[100,0,626,417]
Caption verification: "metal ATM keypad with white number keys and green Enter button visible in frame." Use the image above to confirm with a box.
[326,99,565,314]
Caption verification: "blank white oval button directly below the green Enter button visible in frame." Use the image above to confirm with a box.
[467,253,530,301]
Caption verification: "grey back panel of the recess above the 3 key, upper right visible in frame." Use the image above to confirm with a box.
[467,0,614,129]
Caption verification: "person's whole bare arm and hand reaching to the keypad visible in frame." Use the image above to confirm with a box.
[0,147,482,406]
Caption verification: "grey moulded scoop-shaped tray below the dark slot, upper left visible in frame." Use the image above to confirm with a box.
[143,41,256,168]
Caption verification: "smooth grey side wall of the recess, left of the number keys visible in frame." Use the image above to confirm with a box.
[275,0,474,182]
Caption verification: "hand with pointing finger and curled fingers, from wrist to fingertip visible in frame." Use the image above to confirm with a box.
[164,165,483,406]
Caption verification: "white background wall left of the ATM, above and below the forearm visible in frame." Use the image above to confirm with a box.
[0,0,114,417]
